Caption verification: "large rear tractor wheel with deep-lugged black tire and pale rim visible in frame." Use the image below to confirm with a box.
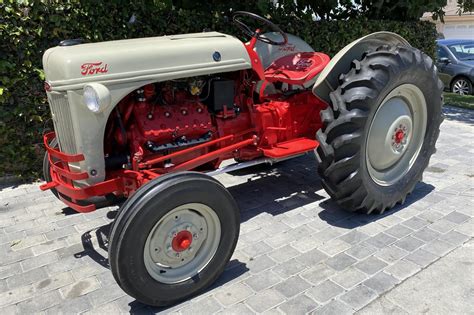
[316,45,443,213]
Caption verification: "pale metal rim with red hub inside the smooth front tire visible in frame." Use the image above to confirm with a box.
[143,203,221,284]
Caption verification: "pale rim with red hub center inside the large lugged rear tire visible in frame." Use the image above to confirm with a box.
[366,84,427,186]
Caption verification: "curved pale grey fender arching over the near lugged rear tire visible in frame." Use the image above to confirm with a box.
[313,32,410,103]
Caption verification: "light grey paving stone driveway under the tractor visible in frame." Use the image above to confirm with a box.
[0,107,474,314]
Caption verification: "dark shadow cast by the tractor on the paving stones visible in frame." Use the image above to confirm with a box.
[75,154,434,313]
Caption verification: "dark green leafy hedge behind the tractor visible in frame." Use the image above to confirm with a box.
[0,0,436,179]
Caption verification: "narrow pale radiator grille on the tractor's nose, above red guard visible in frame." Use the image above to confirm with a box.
[48,93,77,154]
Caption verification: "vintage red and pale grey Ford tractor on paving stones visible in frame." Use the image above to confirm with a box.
[41,12,442,306]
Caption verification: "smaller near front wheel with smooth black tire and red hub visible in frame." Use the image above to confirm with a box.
[109,172,240,306]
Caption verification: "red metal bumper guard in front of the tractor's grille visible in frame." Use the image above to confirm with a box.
[40,132,124,212]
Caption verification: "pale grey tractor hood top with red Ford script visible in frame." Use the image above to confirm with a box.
[43,32,251,90]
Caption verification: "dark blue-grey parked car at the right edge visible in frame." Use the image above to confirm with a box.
[437,39,474,95]
